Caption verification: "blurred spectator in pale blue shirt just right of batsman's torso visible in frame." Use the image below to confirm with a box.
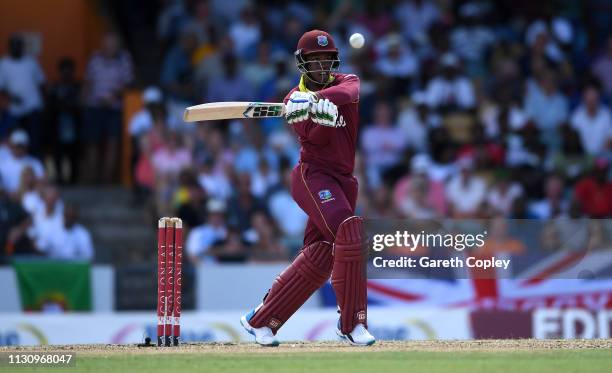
[361,101,406,187]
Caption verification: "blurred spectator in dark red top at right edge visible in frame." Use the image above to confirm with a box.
[574,158,612,218]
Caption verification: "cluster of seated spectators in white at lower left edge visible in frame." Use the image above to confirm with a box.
[0,129,94,263]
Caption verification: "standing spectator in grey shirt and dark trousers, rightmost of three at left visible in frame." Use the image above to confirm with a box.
[82,33,133,183]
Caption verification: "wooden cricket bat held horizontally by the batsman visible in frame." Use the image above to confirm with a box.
[183,102,285,122]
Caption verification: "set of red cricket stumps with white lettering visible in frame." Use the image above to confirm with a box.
[157,217,183,347]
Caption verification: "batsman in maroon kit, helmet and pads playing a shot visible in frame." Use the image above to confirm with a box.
[240,30,375,346]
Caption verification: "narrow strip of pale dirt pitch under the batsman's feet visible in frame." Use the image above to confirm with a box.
[0,339,612,355]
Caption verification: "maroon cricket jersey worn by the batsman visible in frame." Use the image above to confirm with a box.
[284,73,359,174]
